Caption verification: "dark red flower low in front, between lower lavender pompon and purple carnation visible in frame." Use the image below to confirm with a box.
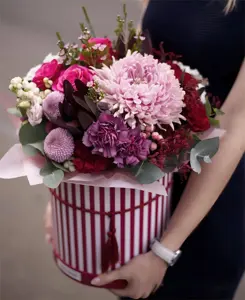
[73,141,112,173]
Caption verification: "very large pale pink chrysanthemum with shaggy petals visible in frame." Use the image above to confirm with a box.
[94,52,185,128]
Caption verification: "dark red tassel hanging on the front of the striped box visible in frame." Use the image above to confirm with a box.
[102,215,119,273]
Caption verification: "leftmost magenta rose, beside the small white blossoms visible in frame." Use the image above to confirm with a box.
[33,59,63,90]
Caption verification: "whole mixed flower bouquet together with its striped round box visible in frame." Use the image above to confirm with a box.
[0,7,224,288]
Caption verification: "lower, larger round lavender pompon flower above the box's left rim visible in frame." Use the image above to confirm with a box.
[44,128,75,163]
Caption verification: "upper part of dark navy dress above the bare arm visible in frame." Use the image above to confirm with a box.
[143,0,245,100]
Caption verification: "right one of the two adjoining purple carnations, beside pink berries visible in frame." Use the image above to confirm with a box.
[114,128,151,168]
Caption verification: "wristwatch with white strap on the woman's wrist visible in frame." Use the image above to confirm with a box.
[151,240,181,267]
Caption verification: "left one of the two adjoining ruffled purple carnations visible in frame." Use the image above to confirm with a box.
[83,113,129,158]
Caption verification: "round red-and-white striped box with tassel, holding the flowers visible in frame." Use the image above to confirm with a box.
[50,175,172,288]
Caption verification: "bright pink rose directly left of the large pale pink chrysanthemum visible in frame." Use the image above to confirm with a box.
[53,65,93,92]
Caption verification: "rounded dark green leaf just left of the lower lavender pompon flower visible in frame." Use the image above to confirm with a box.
[19,122,47,145]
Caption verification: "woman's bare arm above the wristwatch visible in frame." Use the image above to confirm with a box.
[162,60,245,250]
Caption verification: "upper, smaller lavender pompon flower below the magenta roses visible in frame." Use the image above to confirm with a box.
[43,92,64,119]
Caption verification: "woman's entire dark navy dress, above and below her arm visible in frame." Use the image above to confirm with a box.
[124,0,245,300]
